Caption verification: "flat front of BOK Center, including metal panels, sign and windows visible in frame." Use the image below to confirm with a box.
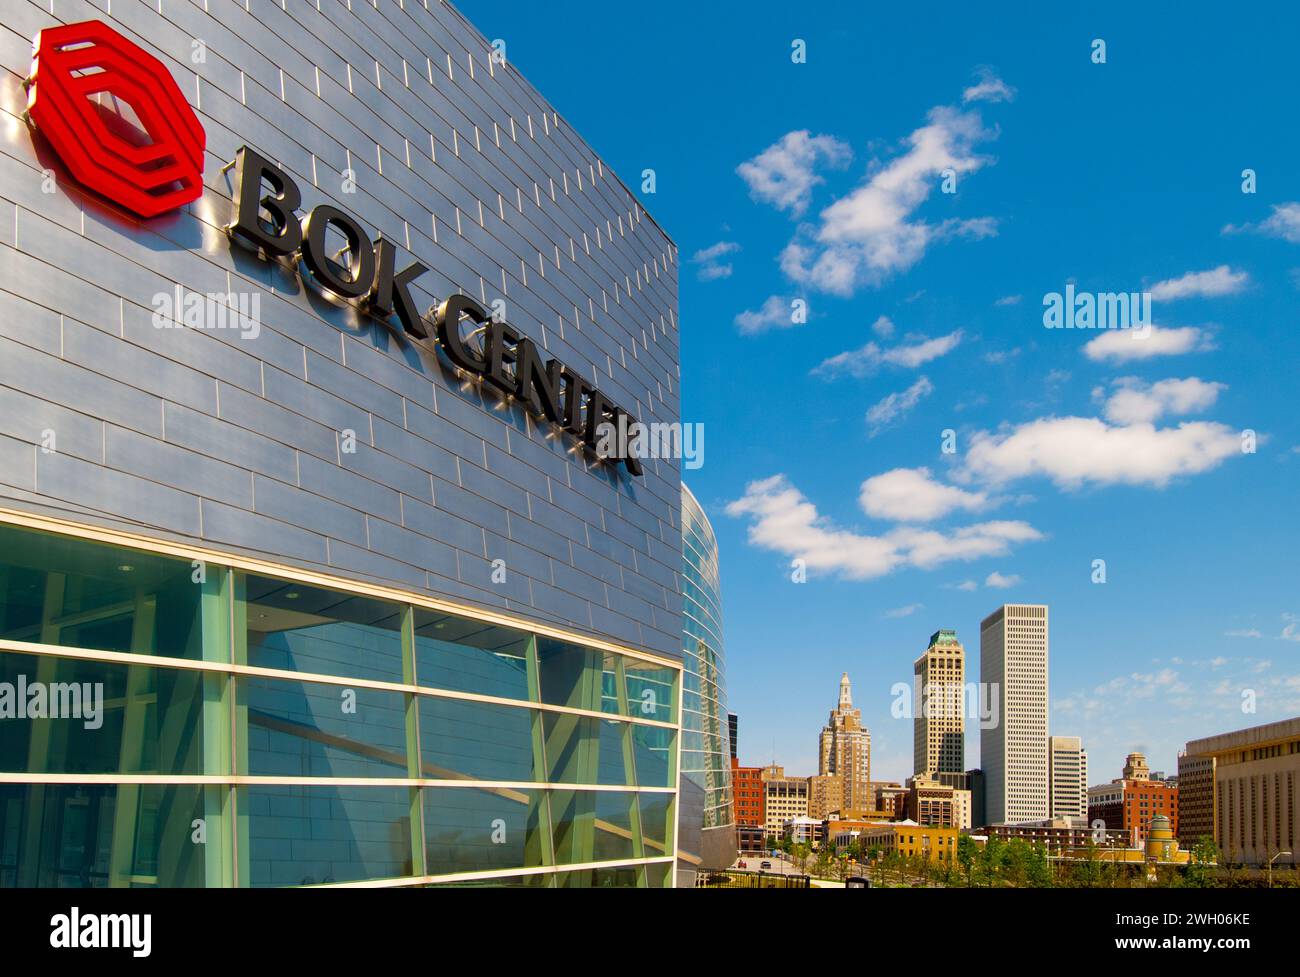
[0,0,702,886]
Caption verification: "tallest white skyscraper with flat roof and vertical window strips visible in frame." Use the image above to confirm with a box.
[979,604,1050,824]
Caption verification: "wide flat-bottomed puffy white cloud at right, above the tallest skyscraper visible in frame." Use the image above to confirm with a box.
[965,417,1242,489]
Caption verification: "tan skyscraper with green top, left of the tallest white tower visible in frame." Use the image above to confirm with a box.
[911,630,966,776]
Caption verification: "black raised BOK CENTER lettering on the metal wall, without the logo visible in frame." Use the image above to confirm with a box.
[226,146,644,476]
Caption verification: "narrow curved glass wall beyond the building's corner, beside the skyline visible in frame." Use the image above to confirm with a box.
[681,485,735,830]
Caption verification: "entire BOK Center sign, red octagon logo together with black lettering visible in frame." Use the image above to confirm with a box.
[26,21,644,476]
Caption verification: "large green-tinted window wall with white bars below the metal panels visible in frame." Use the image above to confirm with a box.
[0,524,681,887]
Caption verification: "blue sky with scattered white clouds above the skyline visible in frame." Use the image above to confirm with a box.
[460,0,1300,782]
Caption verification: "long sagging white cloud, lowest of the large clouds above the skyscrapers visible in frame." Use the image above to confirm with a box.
[727,474,1043,579]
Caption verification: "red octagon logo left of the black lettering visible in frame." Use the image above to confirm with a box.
[27,21,207,217]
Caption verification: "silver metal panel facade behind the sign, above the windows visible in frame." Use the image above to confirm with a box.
[0,0,681,657]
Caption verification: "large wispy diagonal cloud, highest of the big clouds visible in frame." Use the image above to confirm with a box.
[781,107,997,296]
